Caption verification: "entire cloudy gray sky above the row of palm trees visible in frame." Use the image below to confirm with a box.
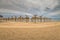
[0,0,60,18]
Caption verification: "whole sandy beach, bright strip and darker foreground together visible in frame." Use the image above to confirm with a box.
[0,22,60,40]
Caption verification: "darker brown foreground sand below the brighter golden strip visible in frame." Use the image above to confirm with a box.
[0,26,60,40]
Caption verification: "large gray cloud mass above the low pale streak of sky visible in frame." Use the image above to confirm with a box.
[0,0,60,16]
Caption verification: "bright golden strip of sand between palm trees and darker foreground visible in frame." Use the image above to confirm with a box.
[0,22,60,28]
